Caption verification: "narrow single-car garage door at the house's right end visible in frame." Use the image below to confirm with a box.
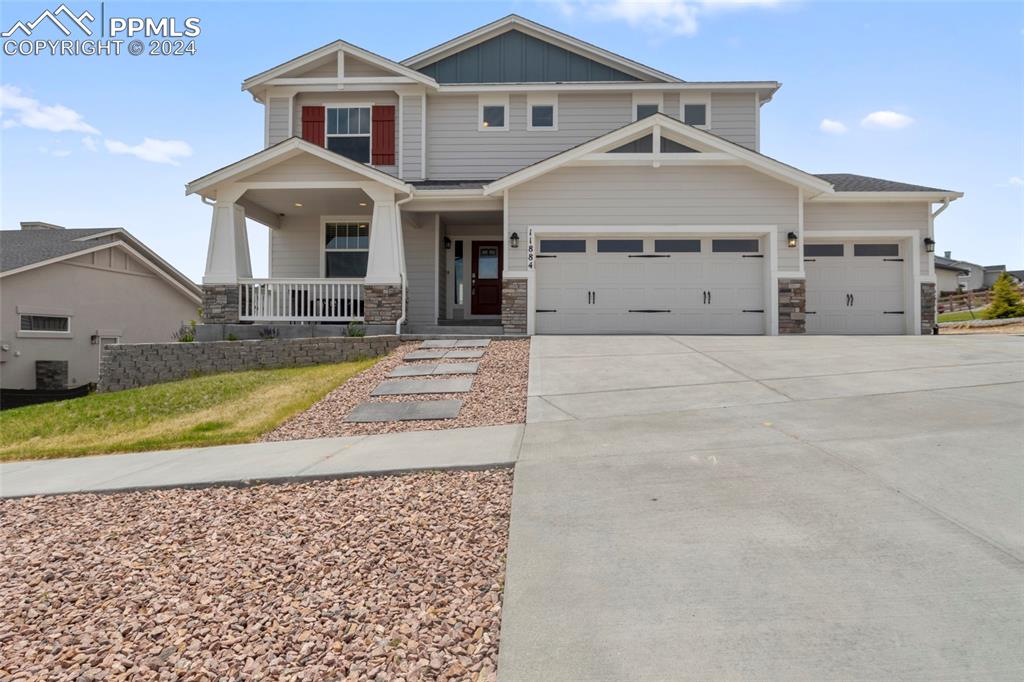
[804,242,907,334]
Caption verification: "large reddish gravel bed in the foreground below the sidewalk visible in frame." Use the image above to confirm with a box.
[0,470,512,681]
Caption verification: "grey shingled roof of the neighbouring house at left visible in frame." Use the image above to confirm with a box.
[0,226,202,303]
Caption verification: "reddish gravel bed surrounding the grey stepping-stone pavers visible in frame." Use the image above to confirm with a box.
[262,339,529,440]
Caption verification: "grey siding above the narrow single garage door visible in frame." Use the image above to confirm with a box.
[804,202,932,275]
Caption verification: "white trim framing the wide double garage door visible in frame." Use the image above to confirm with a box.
[526,225,778,336]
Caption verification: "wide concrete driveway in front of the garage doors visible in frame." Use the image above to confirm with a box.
[499,336,1024,681]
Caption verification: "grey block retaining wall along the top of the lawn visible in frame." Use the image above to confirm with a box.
[97,335,400,392]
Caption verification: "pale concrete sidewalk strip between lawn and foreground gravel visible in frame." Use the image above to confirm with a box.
[0,424,524,498]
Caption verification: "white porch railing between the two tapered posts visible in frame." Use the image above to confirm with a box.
[239,280,362,323]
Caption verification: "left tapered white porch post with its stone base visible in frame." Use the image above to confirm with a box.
[203,187,252,324]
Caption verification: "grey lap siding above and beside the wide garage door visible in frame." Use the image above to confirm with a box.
[508,166,800,272]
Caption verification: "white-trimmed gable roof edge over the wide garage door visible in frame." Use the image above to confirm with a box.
[483,113,833,195]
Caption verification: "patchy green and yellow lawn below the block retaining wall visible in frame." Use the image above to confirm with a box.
[0,358,377,461]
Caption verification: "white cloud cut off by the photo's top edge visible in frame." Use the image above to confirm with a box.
[558,0,780,36]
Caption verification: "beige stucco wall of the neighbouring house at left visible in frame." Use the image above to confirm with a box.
[0,247,199,388]
